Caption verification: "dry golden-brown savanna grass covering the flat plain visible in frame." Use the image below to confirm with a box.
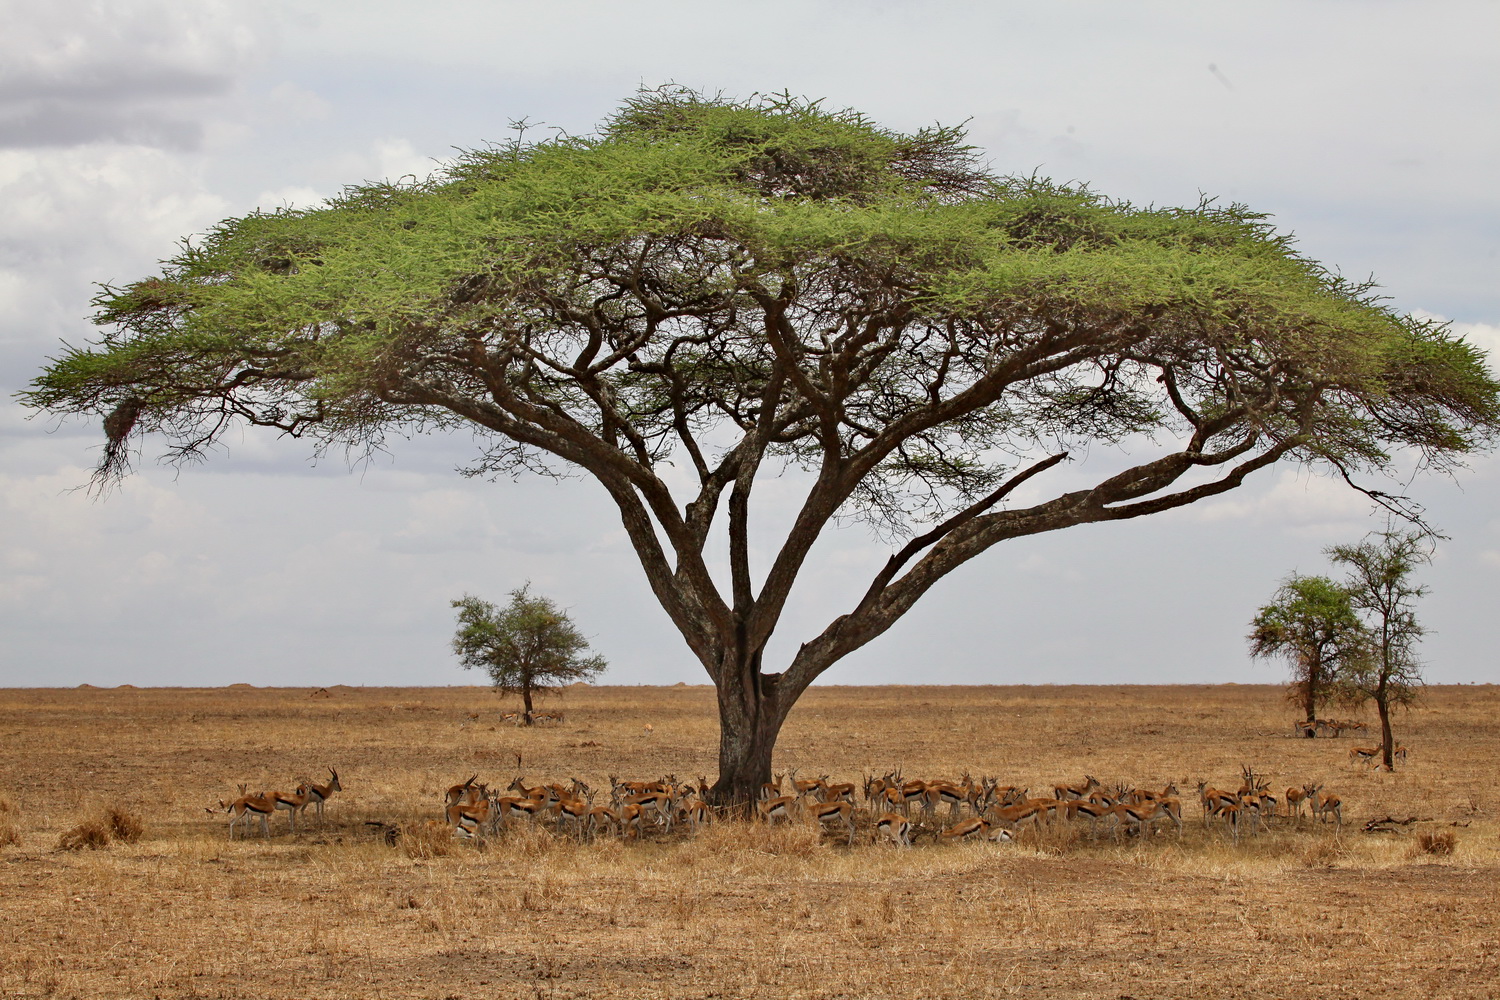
[0,685,1500,1000]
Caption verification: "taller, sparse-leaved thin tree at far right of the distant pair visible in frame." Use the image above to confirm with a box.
[1325,531,1433,771]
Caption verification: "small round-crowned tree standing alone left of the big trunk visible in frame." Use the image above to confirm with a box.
[453,583,606,726]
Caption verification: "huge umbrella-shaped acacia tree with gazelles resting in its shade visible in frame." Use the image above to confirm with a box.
[26,88,1500,802]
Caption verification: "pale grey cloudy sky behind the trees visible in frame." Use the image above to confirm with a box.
[0,0,1500,687]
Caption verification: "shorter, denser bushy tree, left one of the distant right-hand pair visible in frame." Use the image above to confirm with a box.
[1247,574,1365,736]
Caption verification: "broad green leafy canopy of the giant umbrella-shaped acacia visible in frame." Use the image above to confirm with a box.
[26,88,1500,497]
